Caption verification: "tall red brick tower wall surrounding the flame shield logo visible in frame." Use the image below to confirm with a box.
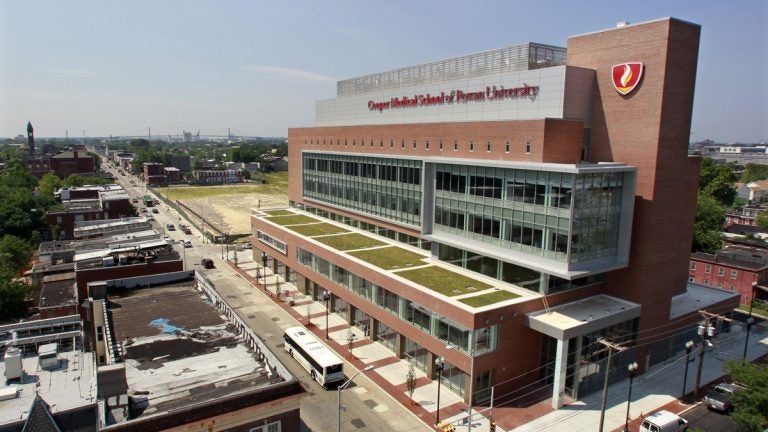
[568,19,700,348]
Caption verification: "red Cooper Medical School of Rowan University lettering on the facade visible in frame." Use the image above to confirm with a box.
[368,83,539,112]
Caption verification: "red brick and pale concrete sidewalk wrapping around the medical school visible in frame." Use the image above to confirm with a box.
[230,253,768,432]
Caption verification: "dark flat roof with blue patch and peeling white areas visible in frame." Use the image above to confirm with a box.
[108,282,285,418]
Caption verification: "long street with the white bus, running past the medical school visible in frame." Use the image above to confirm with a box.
[102,163,432,432]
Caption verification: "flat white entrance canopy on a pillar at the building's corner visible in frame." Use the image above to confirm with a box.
[527,294,640,340]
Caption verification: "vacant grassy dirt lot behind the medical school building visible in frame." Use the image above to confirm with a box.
[155,172,288,235]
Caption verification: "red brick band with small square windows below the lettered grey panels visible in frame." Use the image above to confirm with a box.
[288,119,584,202]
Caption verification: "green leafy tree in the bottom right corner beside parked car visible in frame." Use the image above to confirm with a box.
[725,360,768,432]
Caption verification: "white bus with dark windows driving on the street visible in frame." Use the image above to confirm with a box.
[283,327,344,387]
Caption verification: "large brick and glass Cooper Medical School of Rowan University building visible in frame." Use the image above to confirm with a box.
[252,18,738,407]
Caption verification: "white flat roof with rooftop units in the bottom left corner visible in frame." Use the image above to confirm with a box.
[0,349,96,425]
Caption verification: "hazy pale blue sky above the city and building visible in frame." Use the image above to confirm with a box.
[0,0,768,142]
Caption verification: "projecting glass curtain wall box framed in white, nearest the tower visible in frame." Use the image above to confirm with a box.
[435,164,624,264]
